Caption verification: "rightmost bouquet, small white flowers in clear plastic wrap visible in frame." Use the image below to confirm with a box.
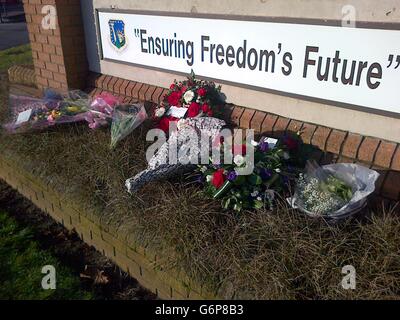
[288,162,379,219]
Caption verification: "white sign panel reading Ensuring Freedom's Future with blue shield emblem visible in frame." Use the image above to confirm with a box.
[98,12,400,113]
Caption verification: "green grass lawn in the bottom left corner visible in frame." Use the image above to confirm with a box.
[0,212,92,300]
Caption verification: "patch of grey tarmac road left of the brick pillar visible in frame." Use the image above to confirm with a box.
[0,22,29,50]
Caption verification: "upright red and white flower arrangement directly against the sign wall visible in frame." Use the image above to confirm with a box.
[154,71,224,132]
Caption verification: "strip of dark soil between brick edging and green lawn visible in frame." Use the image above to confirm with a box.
[0,180,157,300]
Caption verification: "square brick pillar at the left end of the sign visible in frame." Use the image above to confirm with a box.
[23,0,88,91]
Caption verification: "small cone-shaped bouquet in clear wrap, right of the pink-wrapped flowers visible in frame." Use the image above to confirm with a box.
[110,104,147,149]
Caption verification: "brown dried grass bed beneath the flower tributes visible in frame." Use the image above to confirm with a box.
[0,73,400,299]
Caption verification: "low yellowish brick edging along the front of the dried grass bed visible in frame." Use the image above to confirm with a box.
[0,158,216,299]
